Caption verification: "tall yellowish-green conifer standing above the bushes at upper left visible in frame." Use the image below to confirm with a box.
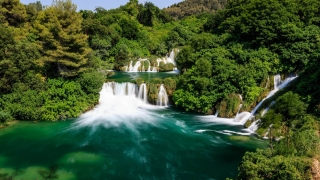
[34,0,91,76]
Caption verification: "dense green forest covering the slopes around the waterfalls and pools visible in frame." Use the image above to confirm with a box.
[0,0,320,179]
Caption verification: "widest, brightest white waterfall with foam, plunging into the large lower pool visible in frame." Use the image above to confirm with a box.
[76,82,158,131]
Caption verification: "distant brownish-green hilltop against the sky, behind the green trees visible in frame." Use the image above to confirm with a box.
[164,0,228,19]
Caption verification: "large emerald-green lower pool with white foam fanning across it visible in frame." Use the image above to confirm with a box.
[0,73,266,180]
